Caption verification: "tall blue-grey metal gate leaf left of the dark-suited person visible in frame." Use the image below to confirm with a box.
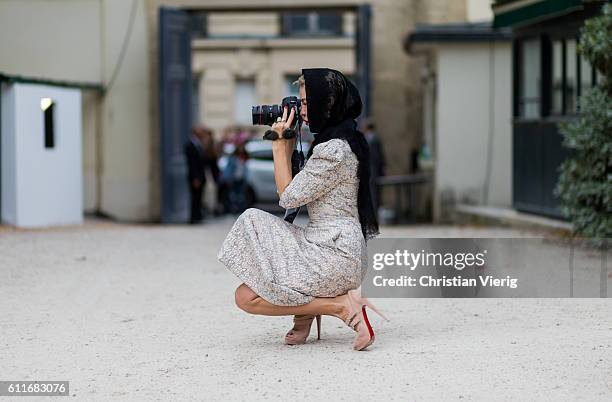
[159,7,192,223]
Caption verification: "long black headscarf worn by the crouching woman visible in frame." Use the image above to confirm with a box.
[302,68,380,241]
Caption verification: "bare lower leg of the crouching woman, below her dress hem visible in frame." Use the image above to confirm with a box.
[235,283,348,321]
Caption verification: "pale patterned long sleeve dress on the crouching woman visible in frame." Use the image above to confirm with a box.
[217,138,367,306]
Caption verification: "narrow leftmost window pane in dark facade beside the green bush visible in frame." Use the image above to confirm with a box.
[518,39,541,118]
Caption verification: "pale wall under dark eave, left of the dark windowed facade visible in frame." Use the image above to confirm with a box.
[435,42,512,215]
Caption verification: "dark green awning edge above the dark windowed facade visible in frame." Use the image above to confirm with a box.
[493,0,583,28]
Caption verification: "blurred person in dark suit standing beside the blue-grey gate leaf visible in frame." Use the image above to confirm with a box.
[185,127,206,224]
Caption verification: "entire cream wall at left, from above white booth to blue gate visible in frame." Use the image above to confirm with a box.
[0,0,152,220]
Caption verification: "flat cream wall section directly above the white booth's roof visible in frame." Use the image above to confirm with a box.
[0,0,102,82]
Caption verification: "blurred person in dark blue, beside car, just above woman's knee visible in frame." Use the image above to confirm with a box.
[223,140,249,213]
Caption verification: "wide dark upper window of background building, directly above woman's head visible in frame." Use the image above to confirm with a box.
[282,12,342,36]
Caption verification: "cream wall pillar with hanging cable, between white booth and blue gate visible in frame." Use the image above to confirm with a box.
[100,0,152,221]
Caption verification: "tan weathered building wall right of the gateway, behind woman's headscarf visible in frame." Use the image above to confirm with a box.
[371,0,466,198]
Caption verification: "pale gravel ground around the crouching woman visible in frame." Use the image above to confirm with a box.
[0,219,612,401]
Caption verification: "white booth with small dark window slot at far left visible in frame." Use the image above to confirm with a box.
[2,84,83,227]
